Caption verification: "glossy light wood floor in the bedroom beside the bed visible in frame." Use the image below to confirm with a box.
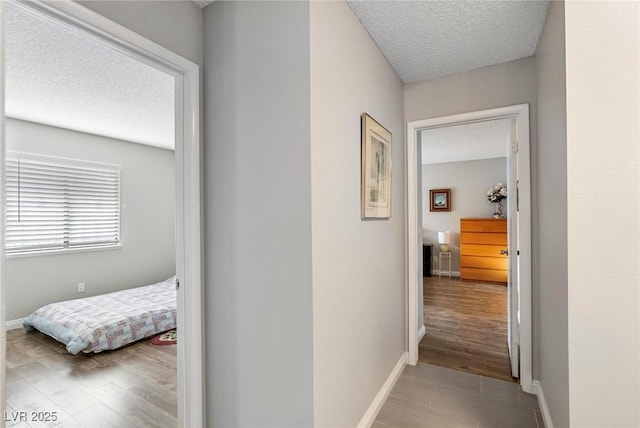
[5,329,177,428]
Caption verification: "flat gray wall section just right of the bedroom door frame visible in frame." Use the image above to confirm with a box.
[204,2,313,427]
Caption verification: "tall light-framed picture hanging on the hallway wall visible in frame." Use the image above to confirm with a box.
[360,113,391,219]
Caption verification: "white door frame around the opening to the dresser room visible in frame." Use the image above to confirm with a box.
[406,104,534,393]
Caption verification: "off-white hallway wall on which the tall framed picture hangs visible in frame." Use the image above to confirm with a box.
[310,2,406,427]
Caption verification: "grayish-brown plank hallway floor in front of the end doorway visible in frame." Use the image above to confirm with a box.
[372,362,544,428]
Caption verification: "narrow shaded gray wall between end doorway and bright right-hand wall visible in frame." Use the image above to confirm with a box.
[536,2,569,427]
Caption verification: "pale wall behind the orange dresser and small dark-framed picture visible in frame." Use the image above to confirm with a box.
[421,158,507,273]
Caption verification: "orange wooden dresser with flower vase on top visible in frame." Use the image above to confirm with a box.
[460,218,509,284]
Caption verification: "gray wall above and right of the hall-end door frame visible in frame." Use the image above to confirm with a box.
[404,57,540,379]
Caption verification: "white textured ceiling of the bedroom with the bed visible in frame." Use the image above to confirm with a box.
[5,3,175,149]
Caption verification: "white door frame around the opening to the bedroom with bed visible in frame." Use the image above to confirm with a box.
[0,1,206,428]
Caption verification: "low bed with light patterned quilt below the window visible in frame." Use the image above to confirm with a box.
[24,276,176,354]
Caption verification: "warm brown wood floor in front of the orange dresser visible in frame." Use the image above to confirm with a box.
[419,277,515,382]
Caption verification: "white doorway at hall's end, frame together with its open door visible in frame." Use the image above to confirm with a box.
[407,104,533,392]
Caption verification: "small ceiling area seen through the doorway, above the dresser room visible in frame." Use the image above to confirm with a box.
[420,119,511,165]
